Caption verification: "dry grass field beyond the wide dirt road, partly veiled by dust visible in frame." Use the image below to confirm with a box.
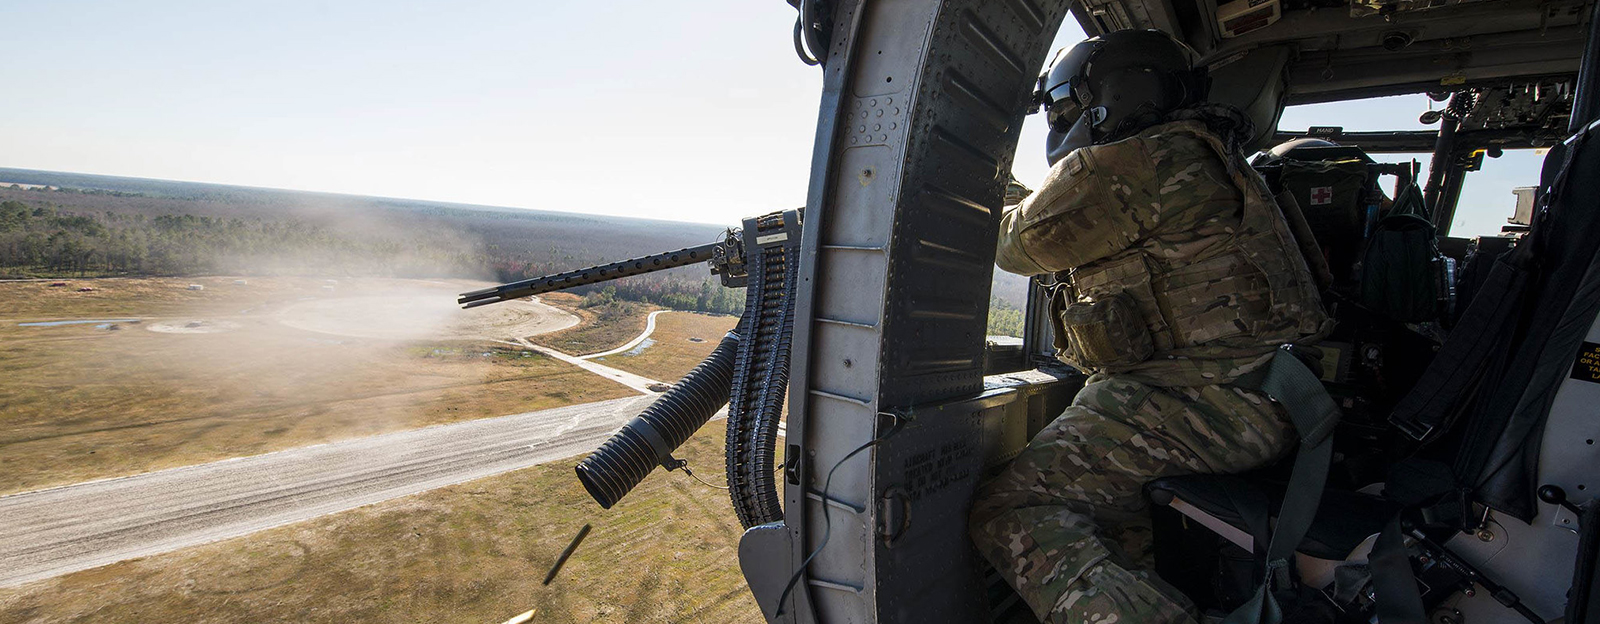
[0,278,632,493]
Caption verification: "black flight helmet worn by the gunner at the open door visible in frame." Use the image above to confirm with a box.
[1034,30,1210,163]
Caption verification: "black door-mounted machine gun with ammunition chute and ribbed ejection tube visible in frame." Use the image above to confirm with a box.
[458,210,802,528]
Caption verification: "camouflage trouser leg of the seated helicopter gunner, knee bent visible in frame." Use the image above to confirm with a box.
[971,376,1294,624]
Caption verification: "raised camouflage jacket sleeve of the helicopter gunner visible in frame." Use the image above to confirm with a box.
[995,138,1160,275]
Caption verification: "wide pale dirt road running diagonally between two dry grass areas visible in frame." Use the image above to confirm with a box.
[0,397,654,587]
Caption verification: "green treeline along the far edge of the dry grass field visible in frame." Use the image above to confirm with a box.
[0,200,744,315]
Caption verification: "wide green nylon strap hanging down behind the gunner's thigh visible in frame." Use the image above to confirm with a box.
[1222,349,1339,624]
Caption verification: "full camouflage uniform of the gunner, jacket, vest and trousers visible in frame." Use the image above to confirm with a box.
[971,122,1330,624]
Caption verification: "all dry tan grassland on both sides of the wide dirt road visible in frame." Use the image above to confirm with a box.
[0,278,760,624]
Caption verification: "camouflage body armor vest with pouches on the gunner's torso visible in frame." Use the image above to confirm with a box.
[1042,122,1331,380]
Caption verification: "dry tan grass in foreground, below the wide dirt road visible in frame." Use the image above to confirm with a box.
[0,422,762,624]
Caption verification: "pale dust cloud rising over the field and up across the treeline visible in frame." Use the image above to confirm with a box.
[128,208,560,437]
